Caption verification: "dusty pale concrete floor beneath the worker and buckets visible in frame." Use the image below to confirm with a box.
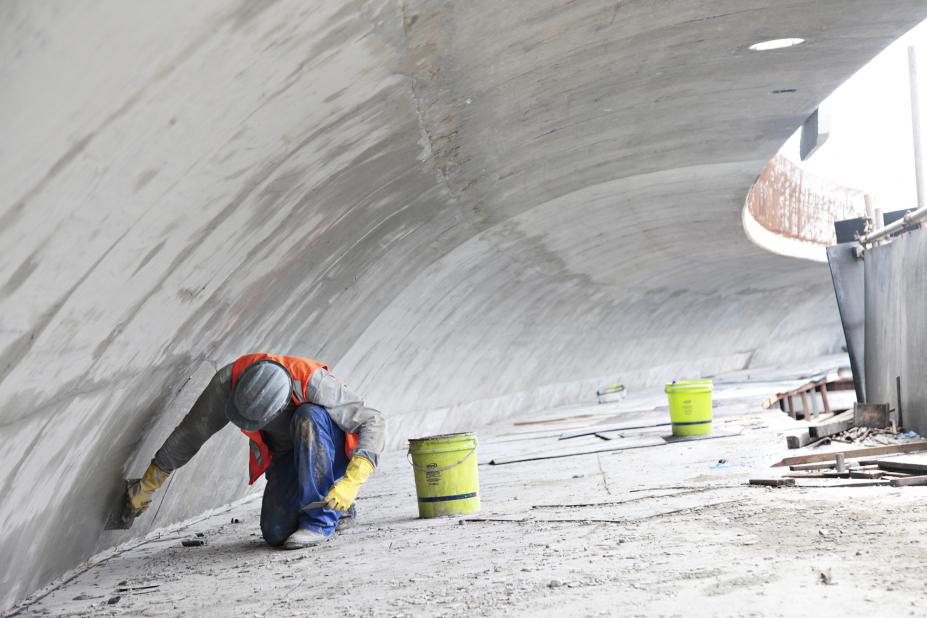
[12,358,927,616]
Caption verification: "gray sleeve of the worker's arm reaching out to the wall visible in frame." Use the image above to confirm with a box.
[151,365,232,472]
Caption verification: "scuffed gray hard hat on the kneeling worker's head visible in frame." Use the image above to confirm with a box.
[225,361,293,431]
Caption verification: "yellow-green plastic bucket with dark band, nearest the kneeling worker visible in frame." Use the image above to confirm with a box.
[409,433,480,518]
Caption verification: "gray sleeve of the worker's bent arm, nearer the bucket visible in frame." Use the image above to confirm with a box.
[306,369,386,466]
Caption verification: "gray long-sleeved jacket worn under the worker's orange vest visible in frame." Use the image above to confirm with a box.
[152,365,386,472]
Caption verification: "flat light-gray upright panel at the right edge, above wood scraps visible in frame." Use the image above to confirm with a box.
[864,230,927,435]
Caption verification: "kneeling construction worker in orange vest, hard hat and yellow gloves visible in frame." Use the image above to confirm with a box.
[125,354,385,549]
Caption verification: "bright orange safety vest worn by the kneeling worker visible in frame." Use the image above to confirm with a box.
[232,354,358,485]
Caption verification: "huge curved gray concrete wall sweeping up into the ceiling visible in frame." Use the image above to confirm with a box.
[0,0,927,607]
